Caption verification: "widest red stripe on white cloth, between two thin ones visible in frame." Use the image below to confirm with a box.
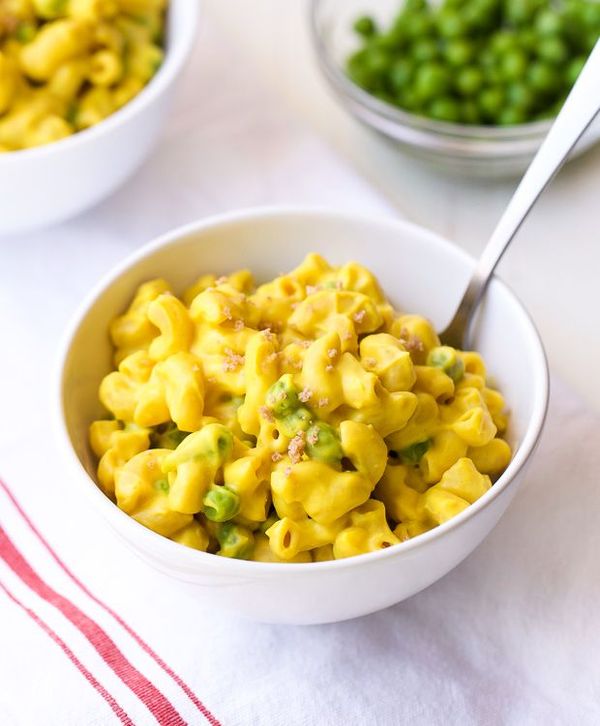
[0,527,186,726]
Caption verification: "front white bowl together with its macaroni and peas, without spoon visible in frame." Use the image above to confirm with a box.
[58,209,548,623]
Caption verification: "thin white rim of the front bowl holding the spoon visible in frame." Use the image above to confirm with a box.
[53,206,550,577]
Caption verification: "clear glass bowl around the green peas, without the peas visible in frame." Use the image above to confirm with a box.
[310,0,600,178]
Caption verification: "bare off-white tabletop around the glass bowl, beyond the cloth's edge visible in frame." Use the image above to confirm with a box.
[203,0,600,411]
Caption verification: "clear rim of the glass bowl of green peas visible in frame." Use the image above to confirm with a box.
[308,0,554,146]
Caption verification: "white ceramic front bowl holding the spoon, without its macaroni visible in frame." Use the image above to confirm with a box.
[57,209,548,623]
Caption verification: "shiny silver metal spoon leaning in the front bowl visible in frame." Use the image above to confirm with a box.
[439,41,600,348]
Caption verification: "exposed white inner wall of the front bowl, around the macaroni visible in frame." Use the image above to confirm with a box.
[61,210,547,524]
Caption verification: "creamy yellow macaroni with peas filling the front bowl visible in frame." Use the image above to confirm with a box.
[90,255,511,563]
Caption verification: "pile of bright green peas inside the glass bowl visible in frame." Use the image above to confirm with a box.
[346,0,600,126]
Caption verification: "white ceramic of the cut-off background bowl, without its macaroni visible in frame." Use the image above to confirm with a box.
[0,0,198,235]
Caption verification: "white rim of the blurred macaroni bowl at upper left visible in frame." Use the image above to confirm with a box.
[0,0,200,168]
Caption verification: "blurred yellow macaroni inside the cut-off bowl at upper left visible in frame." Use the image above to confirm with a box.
[0,0,168,152]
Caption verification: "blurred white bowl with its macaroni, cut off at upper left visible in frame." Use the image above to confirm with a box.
[0,0,198,235]
